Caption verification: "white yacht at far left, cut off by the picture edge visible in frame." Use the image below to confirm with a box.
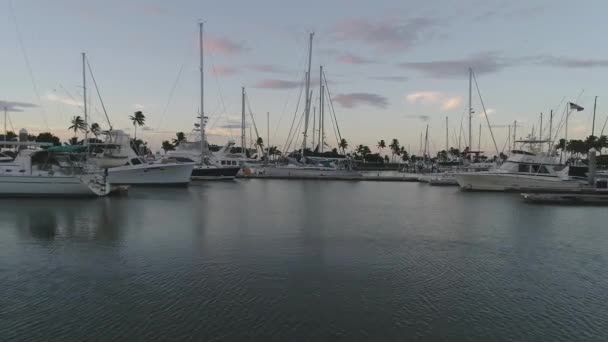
[0,130,110,197]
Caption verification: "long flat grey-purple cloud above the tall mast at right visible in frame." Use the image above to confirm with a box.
[399,52,508,78]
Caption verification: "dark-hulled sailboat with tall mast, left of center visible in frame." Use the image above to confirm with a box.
[164,22,241,180]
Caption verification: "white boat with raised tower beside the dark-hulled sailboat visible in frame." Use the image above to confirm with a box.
[100,130,194,186]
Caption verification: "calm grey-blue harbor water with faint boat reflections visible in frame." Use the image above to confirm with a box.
[0,180,608,341]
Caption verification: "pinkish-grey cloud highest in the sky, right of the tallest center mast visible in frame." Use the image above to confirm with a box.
[332,17,437,52]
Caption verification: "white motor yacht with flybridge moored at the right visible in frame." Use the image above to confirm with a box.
[454,150,588,191]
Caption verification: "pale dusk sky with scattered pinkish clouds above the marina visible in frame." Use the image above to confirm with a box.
[0,0,608,154]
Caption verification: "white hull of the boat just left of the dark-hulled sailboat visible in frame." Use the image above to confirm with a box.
[107,163,194,185]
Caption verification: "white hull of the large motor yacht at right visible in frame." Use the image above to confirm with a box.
[454,172,586,191]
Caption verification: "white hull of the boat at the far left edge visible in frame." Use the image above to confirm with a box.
[0,175,104,197]
